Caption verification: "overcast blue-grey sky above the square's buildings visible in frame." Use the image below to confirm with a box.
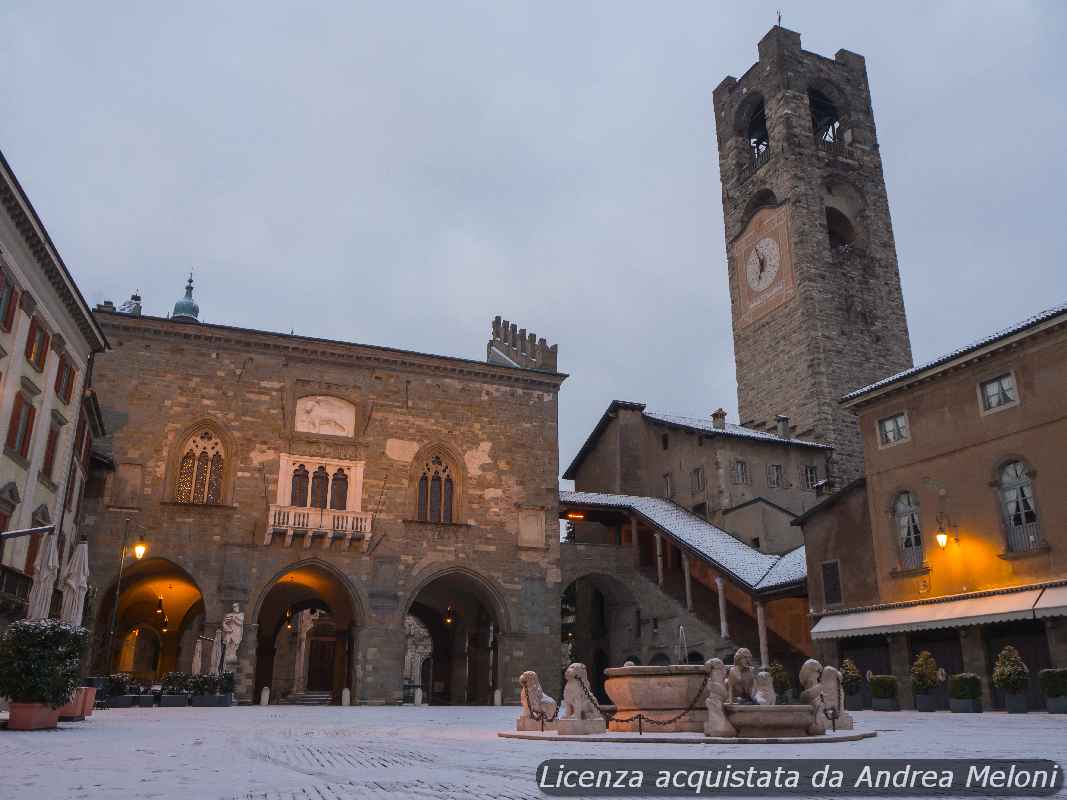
[0,0,1067,482]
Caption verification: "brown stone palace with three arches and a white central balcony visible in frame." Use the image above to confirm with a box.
[86,292,564,703]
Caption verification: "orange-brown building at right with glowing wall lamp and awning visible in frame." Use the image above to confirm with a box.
[797,306,1067,707]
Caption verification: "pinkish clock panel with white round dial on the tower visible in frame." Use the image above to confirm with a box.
[730,205,796,327]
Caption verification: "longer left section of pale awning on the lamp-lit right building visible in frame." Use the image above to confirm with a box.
[811,587,1045,639]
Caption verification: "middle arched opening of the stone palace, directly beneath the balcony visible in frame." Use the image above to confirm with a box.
[255,563,359,704]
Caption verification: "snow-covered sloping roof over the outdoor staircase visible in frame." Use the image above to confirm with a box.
[559,492,808,591]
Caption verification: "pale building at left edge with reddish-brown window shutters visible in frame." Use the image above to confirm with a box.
[0,154,108,625]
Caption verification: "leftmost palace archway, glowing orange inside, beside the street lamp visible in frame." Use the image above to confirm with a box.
[93,558,204,685]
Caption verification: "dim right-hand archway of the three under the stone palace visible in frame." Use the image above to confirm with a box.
[405,572,505,705]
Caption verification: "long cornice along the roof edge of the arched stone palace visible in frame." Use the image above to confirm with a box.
[94,308,567,393]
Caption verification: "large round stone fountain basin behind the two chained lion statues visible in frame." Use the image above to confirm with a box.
[604,665,707,733]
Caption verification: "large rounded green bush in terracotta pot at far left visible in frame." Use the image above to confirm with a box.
[0,620,89,731]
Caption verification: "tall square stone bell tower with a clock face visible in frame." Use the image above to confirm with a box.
[715,27,911,485]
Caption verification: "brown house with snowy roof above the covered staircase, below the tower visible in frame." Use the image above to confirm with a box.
[563,400,831,554]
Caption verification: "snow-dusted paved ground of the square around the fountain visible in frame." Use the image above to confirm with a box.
[0,706,1067,800]
